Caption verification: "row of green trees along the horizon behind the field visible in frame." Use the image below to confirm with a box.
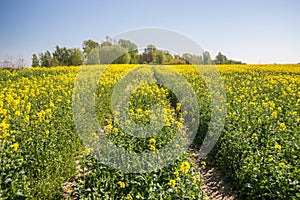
[32,36,243,67]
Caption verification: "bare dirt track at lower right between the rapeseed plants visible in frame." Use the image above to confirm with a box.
[189,150,239,200]
